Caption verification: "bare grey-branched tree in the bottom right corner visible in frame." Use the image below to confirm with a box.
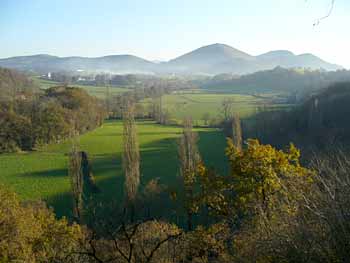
[304,152,350,261]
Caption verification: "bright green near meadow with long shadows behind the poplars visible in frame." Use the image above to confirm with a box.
[0,121,227,220]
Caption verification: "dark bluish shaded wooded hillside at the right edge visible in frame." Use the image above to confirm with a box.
[255,82,350,150]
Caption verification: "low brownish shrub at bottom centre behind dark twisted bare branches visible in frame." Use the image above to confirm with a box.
[74,220,183,263]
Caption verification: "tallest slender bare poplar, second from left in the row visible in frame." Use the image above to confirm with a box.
[123,102,140,221]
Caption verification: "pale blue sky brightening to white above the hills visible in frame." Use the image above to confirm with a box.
[0,0,350,68]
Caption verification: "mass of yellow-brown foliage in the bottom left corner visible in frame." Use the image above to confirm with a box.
[0,187,83,263]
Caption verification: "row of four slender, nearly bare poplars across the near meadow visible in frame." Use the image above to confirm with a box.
[69,97,242,227]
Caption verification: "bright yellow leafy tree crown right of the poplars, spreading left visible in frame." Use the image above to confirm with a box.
[198,139,312,223]
